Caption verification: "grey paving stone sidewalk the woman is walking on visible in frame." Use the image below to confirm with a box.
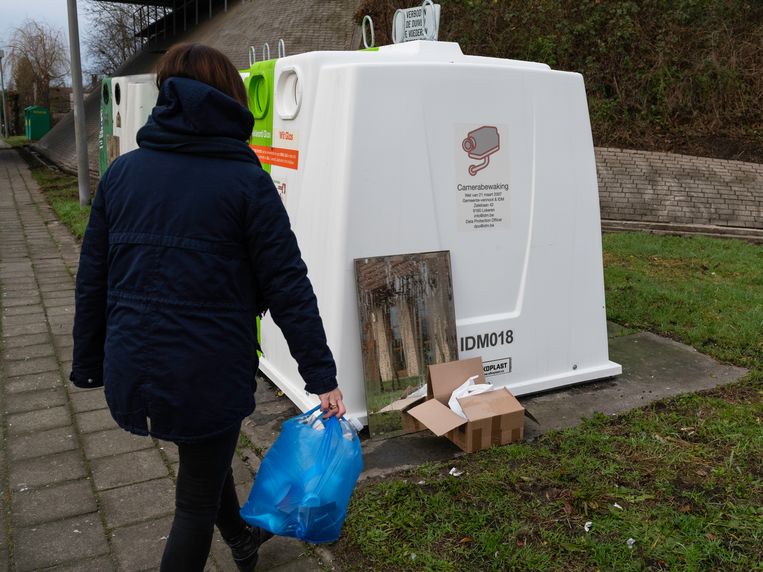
[0,150,325,572]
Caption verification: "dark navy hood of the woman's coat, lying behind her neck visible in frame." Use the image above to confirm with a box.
[137,77,259,164]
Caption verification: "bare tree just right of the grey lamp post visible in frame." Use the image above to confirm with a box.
[82,0,143,75]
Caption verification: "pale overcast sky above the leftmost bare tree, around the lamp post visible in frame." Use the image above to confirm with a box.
[0,0,93,76]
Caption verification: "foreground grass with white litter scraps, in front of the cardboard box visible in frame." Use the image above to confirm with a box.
[342,383,763,571]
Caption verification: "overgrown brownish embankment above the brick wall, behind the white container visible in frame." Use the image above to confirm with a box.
[357,0,763,163]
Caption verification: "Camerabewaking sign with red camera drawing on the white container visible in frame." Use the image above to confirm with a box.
[454,124,511,231]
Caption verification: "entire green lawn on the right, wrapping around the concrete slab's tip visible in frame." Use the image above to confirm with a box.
[333,233,763,572]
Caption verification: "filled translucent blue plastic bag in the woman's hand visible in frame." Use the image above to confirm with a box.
[241,407,363,544]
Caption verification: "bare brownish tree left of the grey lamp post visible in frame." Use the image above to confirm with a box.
[10,20,69,106]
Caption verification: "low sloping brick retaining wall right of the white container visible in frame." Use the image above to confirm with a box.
[596,147,763,229]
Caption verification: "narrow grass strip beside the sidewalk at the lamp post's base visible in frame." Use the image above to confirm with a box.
[16,151,90,240]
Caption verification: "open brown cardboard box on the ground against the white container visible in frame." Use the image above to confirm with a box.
[403,357,525,453]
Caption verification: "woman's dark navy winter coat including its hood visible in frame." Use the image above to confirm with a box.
[70,78,337,441]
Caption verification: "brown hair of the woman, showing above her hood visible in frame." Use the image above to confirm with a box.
[156,44,247,107]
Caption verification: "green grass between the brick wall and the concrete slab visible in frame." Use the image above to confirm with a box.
[604,233,763,369]
